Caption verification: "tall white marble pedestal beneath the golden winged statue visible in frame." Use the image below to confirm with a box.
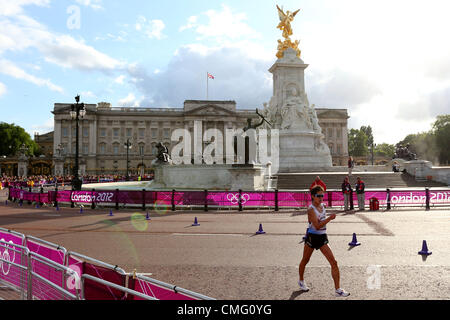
[264,48,332,172]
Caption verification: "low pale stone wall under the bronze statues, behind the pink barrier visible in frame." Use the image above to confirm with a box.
[149,164,265,191]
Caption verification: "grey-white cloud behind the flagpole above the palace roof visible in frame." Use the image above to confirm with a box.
[128,45,272,109]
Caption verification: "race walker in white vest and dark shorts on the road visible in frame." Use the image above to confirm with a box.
[298,186,350,297]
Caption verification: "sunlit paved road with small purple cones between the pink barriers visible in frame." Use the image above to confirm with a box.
[0,193,450,300]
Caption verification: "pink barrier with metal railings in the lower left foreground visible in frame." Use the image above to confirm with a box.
[0,228,212,300]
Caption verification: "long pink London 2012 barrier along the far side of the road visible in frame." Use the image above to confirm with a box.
[8,187,450,211]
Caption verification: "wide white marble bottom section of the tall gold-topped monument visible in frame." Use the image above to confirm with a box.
[278,129,333,173]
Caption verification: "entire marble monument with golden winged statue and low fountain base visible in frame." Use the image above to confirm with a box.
[84,6,332,191]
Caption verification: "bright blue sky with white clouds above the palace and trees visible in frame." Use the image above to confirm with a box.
[0,0,450,143]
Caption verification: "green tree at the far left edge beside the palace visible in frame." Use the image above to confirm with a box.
[0,122,39,156]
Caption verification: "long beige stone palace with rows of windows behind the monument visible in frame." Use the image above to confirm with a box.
[52,100,349,175]
